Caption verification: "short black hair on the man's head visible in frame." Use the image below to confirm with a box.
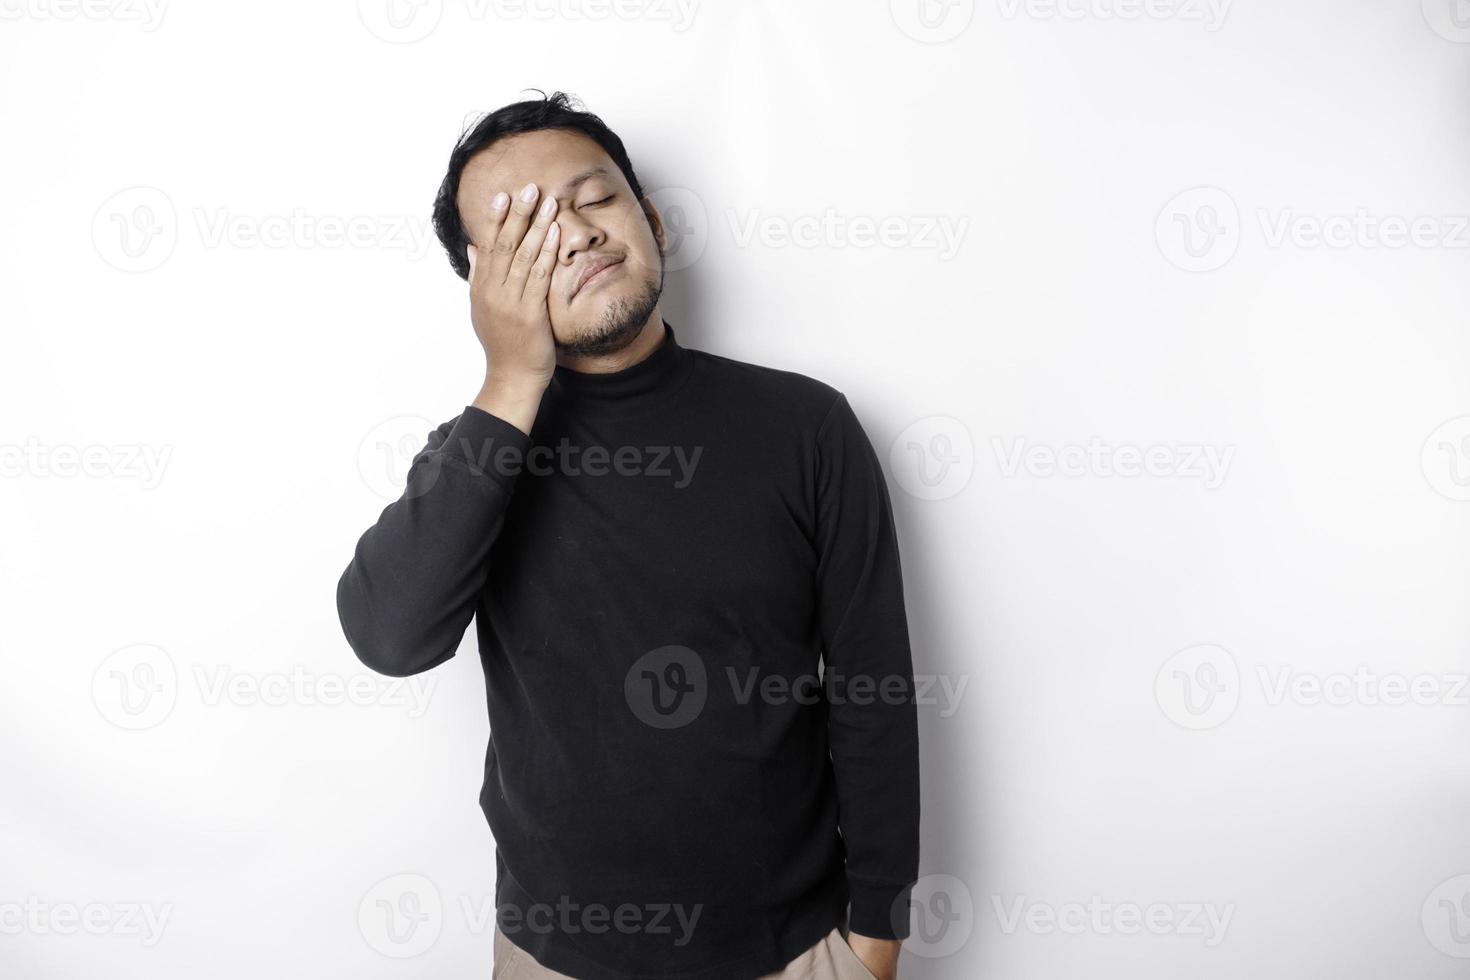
[434,90,644,279]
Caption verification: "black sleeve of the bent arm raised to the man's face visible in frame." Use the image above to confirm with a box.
[337,406,531,677]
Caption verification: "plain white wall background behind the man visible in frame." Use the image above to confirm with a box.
[0,0,1470,980]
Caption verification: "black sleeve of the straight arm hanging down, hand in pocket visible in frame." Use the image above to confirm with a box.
[816,395,919,939]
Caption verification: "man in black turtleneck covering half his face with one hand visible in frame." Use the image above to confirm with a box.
[337,93,919,980]
